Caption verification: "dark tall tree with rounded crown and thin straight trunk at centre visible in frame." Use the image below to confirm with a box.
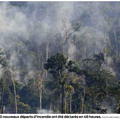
[44,53,71,113]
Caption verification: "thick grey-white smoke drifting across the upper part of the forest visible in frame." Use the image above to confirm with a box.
[0,2,115,80]
